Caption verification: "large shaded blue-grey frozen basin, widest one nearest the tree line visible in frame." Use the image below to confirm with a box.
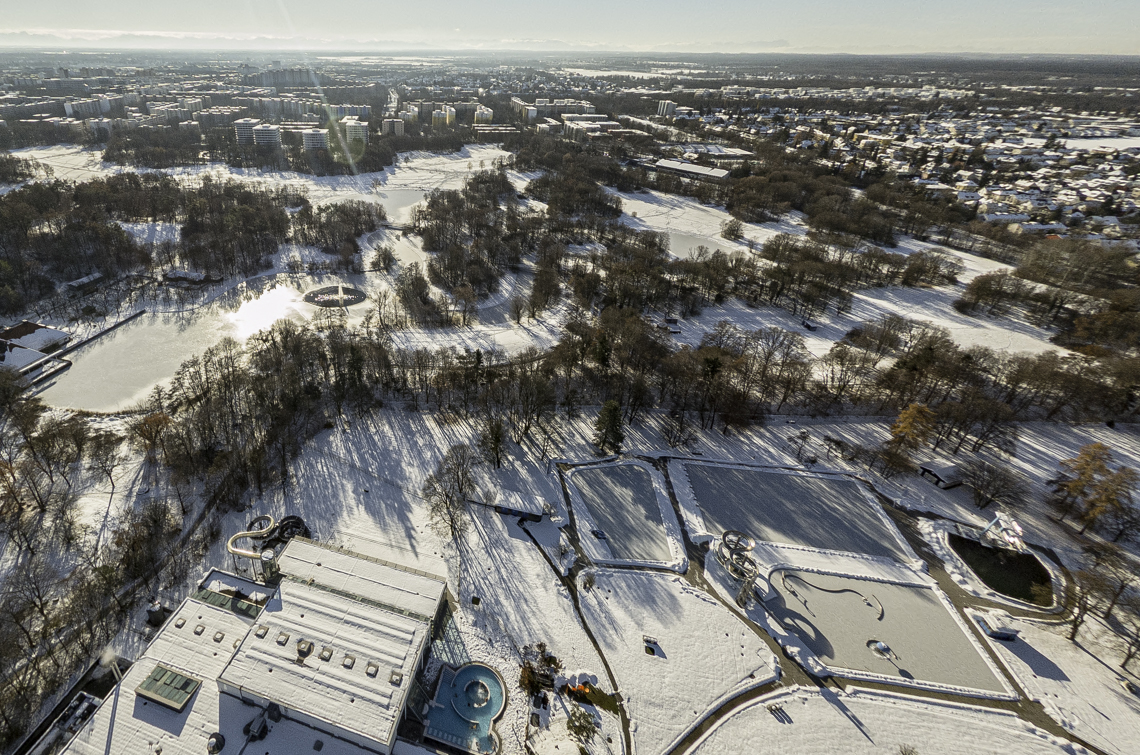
[674,462,915,561]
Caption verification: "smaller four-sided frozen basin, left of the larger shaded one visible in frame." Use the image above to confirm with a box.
[567,462,686,571]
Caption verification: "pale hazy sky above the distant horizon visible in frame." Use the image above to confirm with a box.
[0,0,1140,55]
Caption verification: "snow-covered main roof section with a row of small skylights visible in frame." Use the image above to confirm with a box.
[218,577,431,742]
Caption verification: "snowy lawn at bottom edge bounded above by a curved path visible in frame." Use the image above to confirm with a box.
[690,688,1081,755]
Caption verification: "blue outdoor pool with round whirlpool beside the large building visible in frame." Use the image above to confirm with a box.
[425,664,506,755]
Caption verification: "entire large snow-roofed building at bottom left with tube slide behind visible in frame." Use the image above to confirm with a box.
[63,537,446,755]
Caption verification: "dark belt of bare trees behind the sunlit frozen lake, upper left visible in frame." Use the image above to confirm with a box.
[0,173,384,312]
